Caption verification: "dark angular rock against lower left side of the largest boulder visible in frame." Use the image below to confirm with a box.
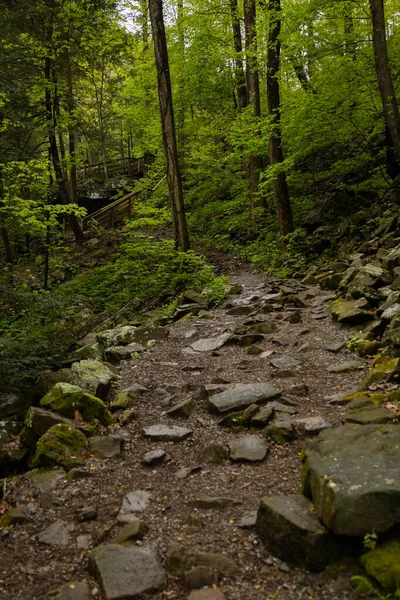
[256,496,339,571]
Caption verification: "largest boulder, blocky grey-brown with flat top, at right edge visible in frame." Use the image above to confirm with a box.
[303,424,400,537]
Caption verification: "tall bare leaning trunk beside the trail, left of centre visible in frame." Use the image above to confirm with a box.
[149,0,190,250]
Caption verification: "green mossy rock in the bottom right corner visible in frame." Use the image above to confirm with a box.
[360,540,400,592]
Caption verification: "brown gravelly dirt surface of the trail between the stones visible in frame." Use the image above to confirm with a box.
[0,262,368,600]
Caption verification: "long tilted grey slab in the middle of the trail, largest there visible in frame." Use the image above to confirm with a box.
[208,383,281,414]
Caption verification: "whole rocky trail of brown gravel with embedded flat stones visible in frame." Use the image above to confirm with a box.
[0,272,397,600]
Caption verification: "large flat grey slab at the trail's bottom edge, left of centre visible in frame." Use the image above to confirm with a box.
[89,544,166,600]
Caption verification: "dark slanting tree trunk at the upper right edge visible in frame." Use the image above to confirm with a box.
[369,0,400,164]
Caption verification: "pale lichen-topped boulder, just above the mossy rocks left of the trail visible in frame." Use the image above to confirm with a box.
[71,360,116,400]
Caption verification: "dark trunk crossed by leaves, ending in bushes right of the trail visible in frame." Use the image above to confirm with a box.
[267,0,293,250]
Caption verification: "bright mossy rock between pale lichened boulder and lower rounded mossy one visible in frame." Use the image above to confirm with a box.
[40,383,113,425]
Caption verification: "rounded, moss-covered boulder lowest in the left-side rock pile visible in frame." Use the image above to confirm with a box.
[31,425,89,469]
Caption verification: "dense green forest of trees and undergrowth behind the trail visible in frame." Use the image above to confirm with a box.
[0,0,400,386]
